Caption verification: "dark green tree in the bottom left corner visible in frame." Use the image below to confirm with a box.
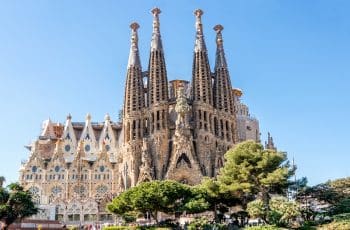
[0,183,38,229]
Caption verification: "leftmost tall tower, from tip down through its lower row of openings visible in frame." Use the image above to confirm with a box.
[123,22,145,143]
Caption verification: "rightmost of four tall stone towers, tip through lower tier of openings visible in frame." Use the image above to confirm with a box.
[213,25,236,144]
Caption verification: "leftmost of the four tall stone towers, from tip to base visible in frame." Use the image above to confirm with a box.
[120,22,145,188]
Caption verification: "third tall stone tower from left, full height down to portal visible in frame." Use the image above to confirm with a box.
[192,10,215,176]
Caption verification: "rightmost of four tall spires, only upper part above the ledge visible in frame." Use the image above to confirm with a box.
[213,25,234,115]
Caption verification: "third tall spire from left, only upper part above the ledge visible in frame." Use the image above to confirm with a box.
[192,9,213,105]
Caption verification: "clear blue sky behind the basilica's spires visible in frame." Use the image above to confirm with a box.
[0,0,350,184]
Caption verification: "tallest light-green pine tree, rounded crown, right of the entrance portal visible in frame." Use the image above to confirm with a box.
[218,141,295,209]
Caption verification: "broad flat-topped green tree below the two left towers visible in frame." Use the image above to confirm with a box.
[107,180,192,222]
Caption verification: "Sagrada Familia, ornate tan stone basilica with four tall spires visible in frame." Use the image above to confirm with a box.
[20,8,275,223]
